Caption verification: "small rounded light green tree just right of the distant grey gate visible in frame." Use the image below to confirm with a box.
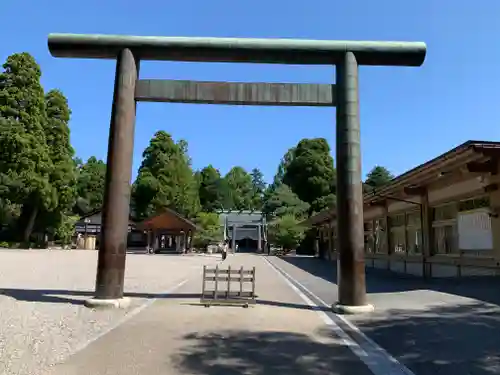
[269,215,304,250]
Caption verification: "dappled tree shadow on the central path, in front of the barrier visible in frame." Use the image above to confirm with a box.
[173,331,371,375]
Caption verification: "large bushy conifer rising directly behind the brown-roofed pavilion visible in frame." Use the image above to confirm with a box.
[132,131,200,218]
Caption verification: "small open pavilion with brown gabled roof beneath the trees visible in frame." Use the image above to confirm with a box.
[137,208,198,254]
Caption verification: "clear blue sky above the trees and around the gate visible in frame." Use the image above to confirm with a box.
[0,0,500,184]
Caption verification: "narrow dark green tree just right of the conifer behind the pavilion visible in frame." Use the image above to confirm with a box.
[198,164,224,212]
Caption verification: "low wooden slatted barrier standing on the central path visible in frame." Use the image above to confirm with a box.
[200,266,256,307]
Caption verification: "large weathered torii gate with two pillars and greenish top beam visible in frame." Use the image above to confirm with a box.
[48,34,426,313]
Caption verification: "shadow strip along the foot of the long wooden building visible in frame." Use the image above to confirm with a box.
[280,256,500,306]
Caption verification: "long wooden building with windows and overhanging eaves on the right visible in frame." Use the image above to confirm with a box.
[305,141,500,277]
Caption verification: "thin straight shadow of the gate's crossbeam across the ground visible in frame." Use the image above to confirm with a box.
[0,288,329,311]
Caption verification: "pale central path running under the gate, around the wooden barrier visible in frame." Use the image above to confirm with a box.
[47,254,376,375]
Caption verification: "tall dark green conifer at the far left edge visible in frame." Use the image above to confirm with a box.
[0,53,57,242]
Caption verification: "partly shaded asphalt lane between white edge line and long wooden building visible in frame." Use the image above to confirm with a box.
[269,257,500,375]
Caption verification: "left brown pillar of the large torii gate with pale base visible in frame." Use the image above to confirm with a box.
[86,48,139,307]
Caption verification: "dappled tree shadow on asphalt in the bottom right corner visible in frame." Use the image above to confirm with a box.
[346,302,500,375]
